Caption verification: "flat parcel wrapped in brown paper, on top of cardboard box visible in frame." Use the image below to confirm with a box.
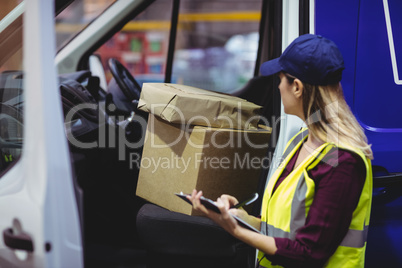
[138,83,261,129]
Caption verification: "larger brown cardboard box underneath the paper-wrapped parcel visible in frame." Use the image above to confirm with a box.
[137,114,271,215]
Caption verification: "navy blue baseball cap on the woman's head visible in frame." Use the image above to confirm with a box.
[260,34,345,85]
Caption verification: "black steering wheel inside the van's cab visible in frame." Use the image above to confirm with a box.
[108,58,141,101]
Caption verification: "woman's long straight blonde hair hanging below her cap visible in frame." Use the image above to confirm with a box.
[302,83,373,159]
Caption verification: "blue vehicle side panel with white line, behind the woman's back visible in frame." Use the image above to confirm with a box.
[315,0,402,267]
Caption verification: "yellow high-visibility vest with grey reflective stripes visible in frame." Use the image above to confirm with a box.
[258,129,372,267]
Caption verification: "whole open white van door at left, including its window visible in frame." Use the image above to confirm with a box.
[0,0,83,267]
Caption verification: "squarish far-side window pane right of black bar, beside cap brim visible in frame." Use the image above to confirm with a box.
[172,0,262,93]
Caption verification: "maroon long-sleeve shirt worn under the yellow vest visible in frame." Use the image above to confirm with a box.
[267,147,366,267]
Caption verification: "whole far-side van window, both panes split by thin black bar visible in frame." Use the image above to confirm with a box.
[95,0,262,93]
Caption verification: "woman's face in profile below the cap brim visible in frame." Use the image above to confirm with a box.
[279,72,303,117]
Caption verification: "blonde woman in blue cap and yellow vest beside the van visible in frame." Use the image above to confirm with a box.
[188,34,373,267]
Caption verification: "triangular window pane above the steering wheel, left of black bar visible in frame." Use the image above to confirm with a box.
[94,0,172,85]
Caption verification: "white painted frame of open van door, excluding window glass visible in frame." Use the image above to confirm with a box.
[0,0,83,267]
